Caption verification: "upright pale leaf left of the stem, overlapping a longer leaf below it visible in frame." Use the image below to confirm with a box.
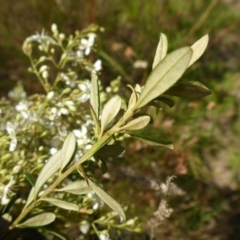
[60,132,76,171]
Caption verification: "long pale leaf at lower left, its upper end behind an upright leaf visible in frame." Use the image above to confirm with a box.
[34,150,62,196]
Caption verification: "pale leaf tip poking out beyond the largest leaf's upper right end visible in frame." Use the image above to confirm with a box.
[188,35,209,67]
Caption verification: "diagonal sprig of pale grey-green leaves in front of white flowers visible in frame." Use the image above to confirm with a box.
[8,31,210,235]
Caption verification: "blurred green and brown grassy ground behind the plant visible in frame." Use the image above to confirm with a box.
[0,0,240,240]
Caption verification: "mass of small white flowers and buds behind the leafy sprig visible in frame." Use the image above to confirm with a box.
[0,24,128,239]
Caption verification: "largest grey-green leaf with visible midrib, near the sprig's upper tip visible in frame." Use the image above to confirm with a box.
[136,47,192,108]
